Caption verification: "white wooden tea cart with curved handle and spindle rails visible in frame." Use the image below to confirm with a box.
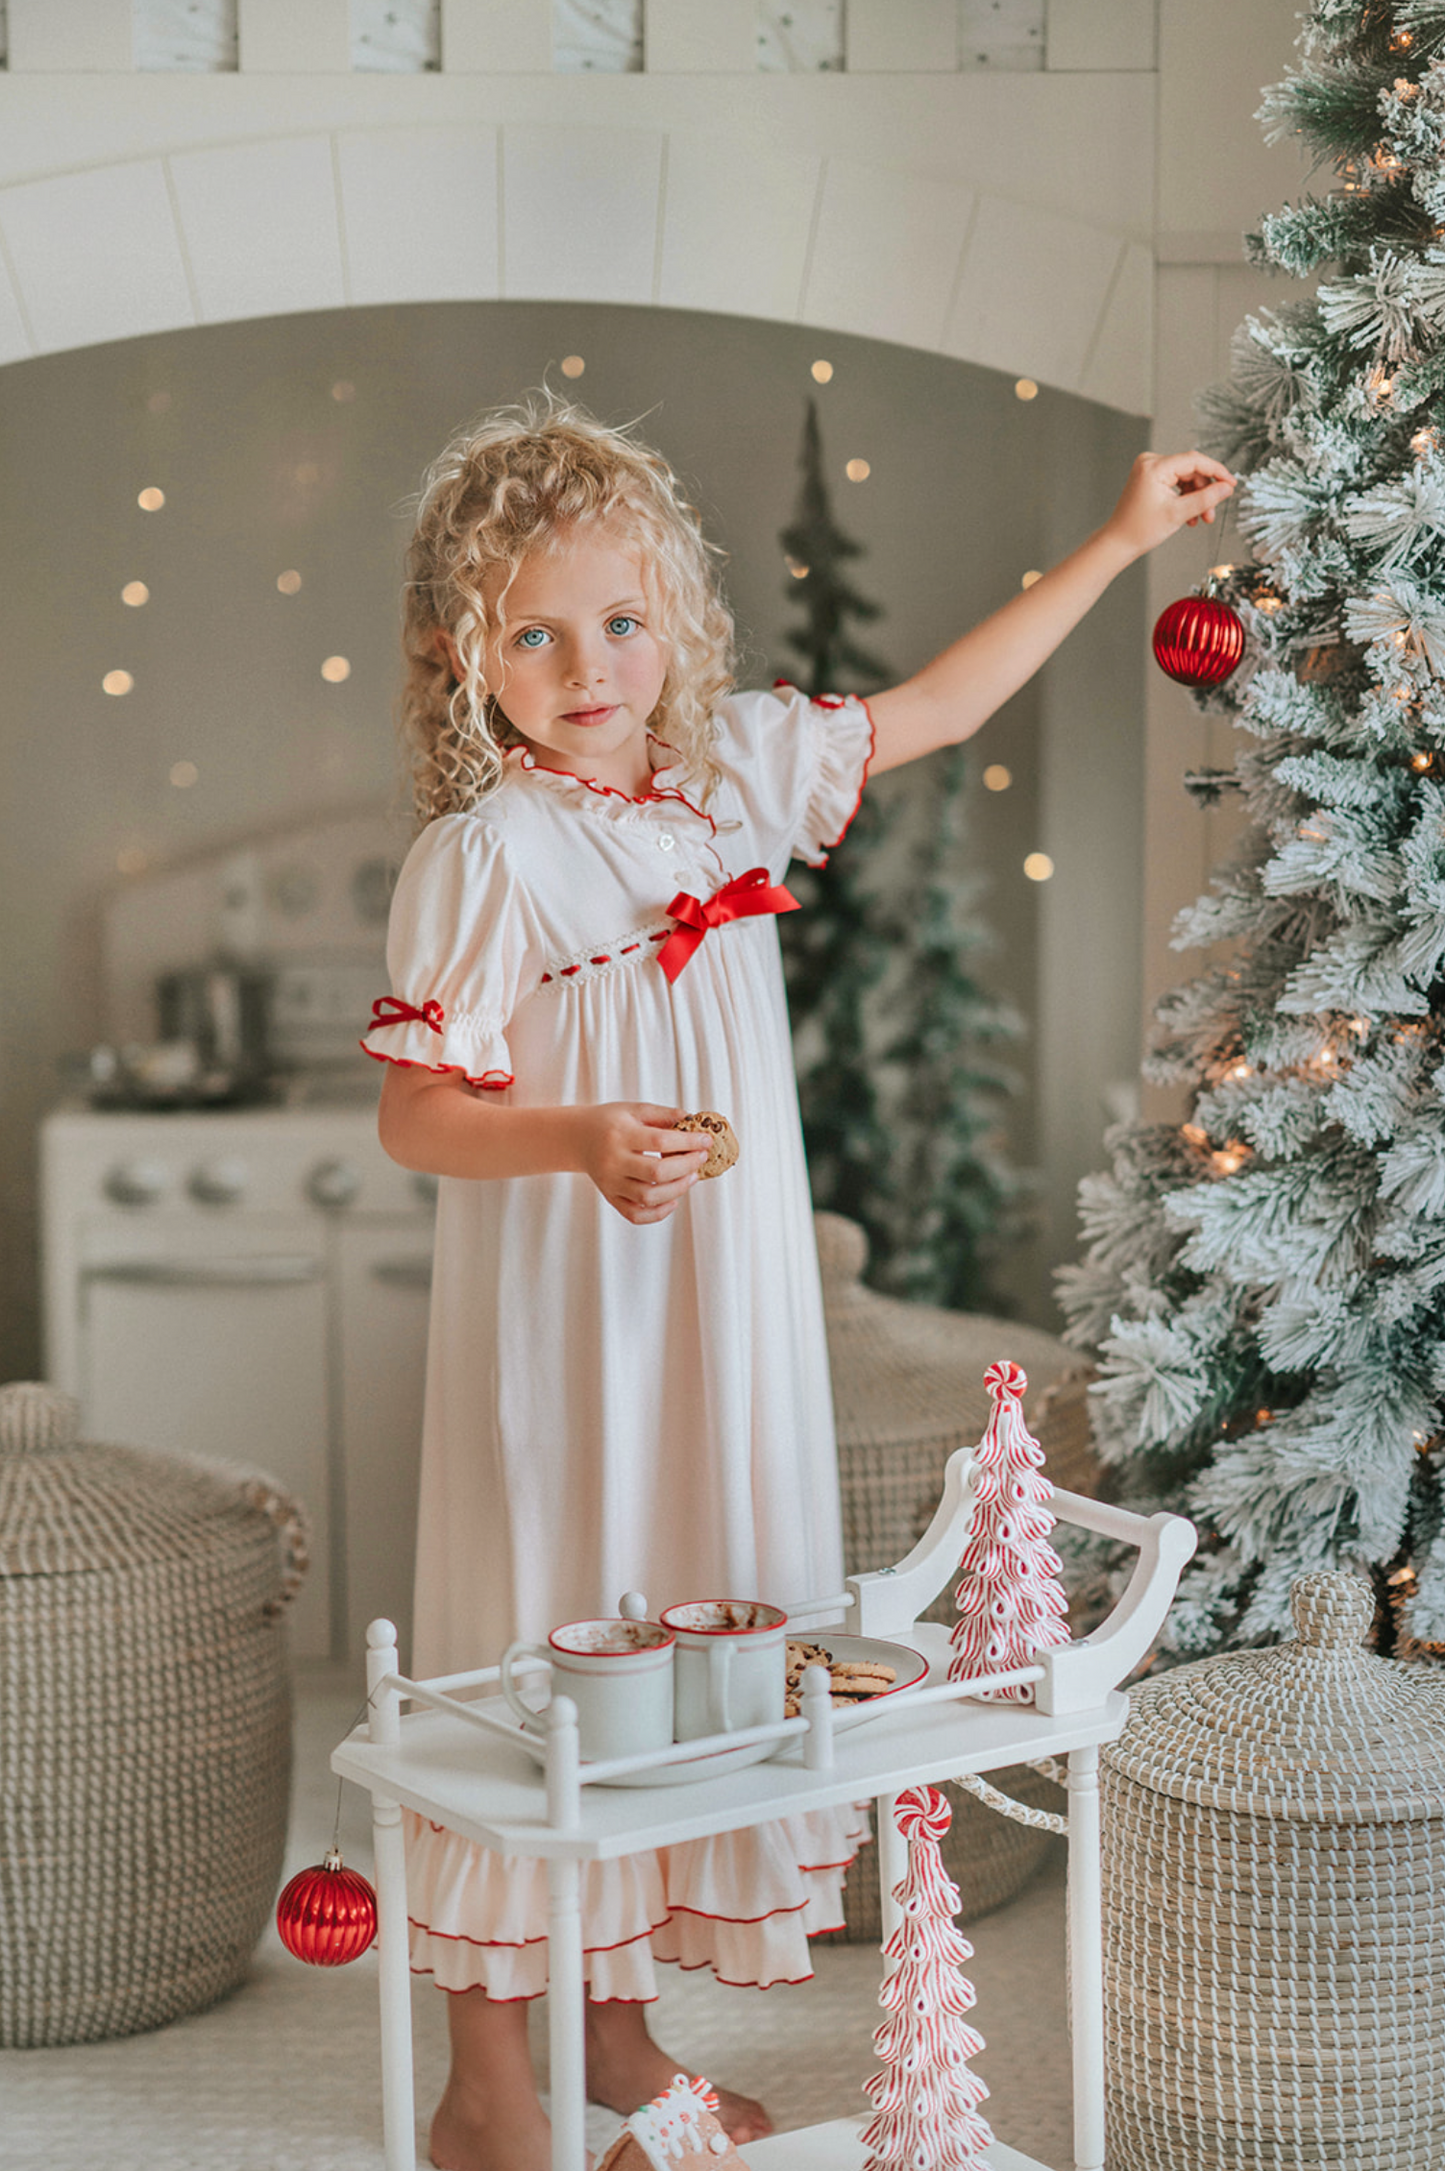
[332,1448,1195,2171]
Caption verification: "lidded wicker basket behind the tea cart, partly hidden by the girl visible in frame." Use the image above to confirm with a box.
[814,1214,1084,1943]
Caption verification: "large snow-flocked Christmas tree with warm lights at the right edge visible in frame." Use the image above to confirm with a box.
[1063,0,1445,1652]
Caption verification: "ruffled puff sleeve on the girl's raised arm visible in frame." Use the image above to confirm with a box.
[718,682,872,866]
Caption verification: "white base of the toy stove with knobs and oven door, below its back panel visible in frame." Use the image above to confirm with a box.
[41,1107,434,1661]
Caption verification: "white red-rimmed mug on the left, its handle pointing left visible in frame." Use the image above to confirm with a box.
[501,1620,673,1763]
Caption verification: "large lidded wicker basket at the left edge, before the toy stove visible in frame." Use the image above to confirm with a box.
[0,1383,306,2049]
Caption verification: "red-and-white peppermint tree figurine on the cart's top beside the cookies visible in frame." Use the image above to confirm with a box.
[948,1359,1070,1704]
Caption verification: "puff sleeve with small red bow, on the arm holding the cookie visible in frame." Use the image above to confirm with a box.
[362,814,545,1090]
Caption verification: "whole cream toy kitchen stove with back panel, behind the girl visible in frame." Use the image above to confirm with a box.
[41,821,436,1659]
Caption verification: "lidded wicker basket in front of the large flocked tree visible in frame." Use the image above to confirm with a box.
[1102,1572,1445,2171]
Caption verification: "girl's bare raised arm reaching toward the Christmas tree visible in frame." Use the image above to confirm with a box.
[868,452,1235,775]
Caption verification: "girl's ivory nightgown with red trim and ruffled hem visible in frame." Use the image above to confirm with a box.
[365,688,872,1999]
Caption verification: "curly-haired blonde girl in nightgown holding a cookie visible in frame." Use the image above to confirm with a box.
[365,402,1232,2171]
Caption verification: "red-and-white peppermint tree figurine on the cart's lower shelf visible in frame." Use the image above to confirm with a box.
[864,1787,994,2171]
